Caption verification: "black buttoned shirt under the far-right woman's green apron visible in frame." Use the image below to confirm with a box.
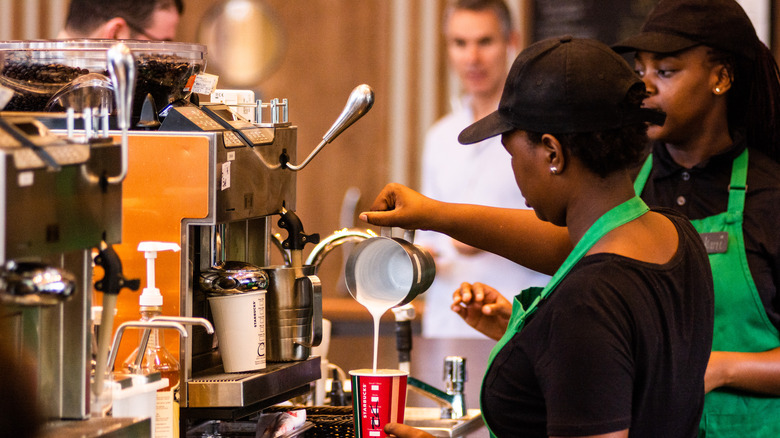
[642,142,780,330]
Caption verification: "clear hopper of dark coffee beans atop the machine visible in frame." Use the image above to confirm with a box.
[0,39,206,122]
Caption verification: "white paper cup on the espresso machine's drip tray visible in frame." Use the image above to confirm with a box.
[209,290,266,373]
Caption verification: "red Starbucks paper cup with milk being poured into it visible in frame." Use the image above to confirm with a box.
[349,369,408,438]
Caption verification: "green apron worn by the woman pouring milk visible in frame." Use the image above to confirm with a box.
[480,196,649,437]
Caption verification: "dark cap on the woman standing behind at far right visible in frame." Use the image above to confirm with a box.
[613,0,761,60]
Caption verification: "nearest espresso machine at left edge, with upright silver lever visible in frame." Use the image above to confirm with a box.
[0,45,140,433]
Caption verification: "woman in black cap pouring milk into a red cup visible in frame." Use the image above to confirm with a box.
[376,37,713,437]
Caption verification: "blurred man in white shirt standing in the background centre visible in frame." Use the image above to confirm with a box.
[415,0,549,339]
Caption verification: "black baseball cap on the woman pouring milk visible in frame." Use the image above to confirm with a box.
[458,36,665,144]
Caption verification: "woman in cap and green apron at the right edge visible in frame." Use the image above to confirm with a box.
[615,0,780,438]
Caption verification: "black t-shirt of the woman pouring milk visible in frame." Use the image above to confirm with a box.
[482,210,713,438]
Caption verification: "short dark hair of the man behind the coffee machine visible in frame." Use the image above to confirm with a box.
[65,0,184,35]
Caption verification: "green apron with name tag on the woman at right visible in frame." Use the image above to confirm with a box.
[634,149,780,438]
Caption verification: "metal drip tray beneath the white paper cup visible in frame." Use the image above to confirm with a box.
[187,357,320,408]
